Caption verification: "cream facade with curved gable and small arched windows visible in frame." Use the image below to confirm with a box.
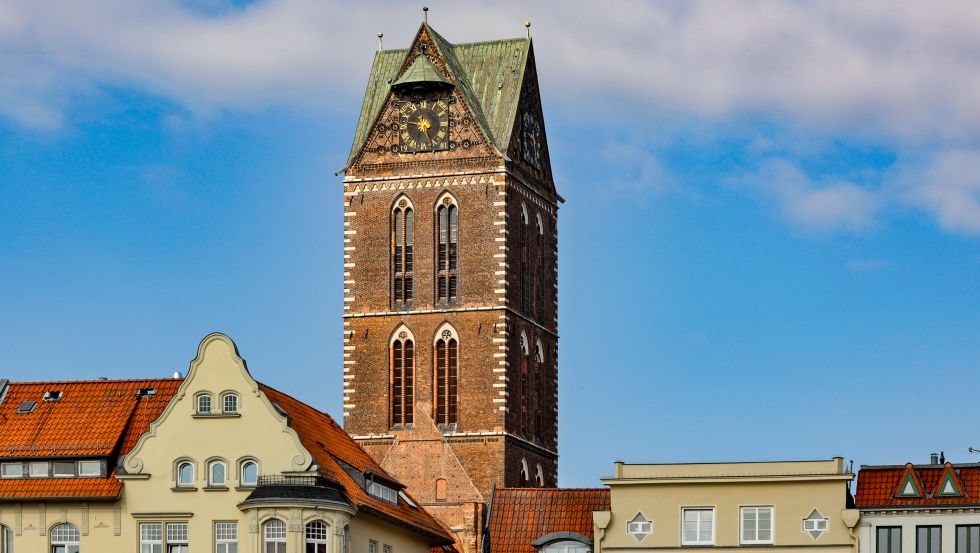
[0,334,444,553]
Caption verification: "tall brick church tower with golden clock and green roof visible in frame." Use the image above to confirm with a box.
[343,18,562,552]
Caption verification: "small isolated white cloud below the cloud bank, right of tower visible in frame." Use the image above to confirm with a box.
[735,160,882,232]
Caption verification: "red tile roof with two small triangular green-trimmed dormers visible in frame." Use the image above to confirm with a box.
[854,463,980,508]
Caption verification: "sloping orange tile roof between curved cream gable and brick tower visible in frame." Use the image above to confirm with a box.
[259,383,452,545]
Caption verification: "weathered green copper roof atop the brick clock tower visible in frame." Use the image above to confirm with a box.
[347,23,531,165]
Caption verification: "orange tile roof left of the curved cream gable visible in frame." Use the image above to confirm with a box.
[0,379,182,501]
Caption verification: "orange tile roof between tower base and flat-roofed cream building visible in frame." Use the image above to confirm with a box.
[488,488,609,553]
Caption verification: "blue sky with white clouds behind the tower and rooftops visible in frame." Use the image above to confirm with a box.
[0,0,980,486]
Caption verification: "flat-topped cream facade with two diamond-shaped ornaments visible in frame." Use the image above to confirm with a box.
[593,458,858,553]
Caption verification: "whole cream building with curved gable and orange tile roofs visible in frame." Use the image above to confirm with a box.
[0,334,451,553]
